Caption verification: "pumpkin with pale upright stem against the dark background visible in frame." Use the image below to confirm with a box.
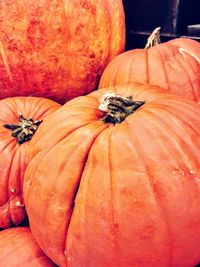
[99,28,200,102]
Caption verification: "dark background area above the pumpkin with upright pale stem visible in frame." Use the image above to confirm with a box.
[123,0,200,50]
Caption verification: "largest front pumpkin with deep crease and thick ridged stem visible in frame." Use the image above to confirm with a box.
[23,83,200,267]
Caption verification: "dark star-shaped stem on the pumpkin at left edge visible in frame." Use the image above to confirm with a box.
[4,114,42,144]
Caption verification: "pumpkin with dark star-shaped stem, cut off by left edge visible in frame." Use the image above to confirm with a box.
[0,97,60,229]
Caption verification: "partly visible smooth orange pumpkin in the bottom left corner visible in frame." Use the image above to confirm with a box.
[0,227,56,267]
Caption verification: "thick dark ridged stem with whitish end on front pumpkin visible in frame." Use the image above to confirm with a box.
[99,93,145,124]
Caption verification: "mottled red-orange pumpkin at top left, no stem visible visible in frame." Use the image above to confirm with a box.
[0,0,125,103]
